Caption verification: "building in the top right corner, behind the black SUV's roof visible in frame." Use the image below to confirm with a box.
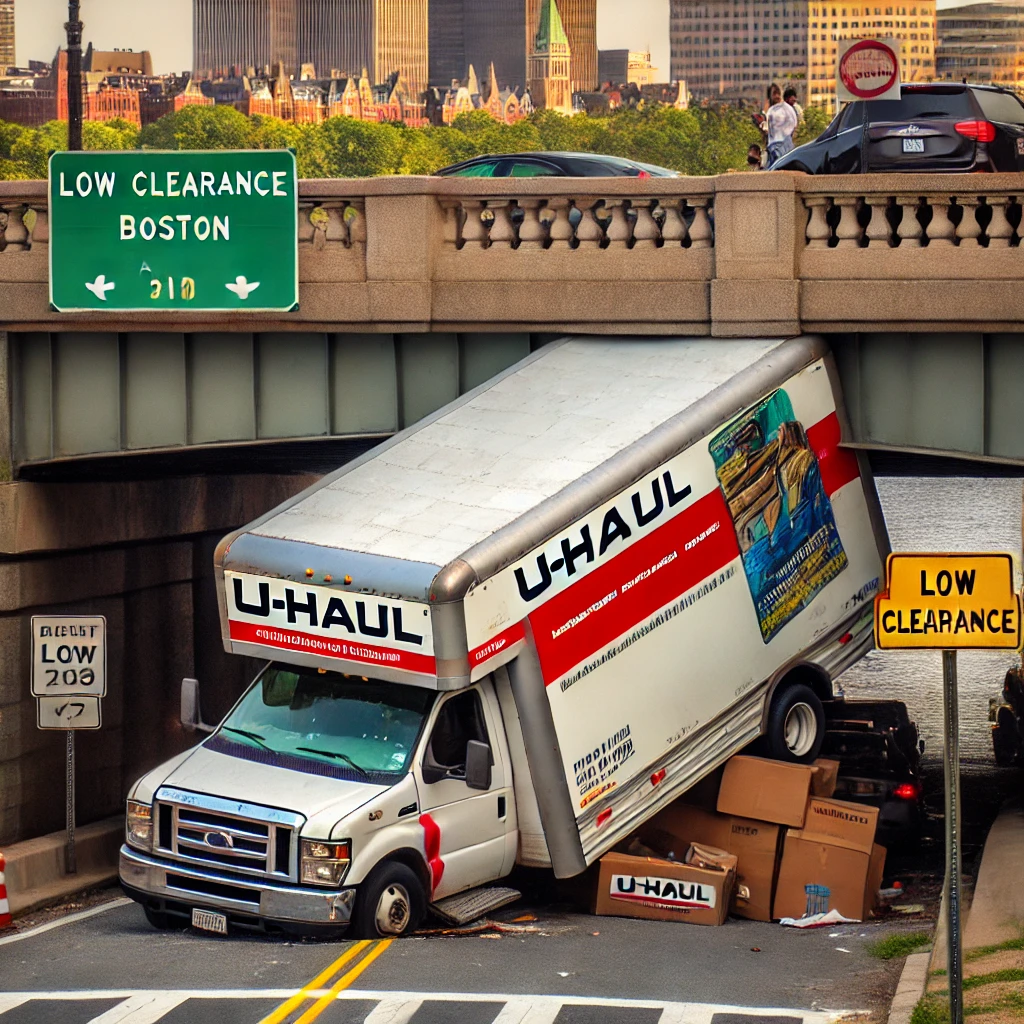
[935,0,1024,89]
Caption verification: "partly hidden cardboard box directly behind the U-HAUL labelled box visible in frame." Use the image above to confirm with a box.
[641,795,783,921]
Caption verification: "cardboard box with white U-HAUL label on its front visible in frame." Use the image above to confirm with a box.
[594,853,736,925]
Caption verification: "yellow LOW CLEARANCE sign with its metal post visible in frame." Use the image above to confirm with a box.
[874,552,1021,1024]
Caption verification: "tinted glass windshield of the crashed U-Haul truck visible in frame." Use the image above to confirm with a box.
[218,665,434,775]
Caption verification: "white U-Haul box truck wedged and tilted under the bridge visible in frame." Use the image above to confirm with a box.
[121,337,887,936]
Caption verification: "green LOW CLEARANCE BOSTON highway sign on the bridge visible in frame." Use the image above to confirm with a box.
[49,150,299,312]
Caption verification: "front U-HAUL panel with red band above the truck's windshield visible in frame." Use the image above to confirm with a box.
[224,571,435,674]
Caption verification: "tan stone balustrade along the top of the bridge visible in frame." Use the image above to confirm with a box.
[6,173,1024,337]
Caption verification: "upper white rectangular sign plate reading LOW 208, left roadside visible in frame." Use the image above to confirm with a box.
[32,615,106,696]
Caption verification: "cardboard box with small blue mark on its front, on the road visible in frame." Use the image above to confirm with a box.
[773,831,886,921]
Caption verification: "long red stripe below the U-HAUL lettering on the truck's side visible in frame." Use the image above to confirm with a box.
[529,488,739,684]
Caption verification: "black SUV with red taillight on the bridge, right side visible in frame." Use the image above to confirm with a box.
[772,82,1024,174]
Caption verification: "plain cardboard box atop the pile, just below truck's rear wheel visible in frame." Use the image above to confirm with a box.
[718,755,816,828]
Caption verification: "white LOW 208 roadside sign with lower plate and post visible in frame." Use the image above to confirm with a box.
[32,615,106,874]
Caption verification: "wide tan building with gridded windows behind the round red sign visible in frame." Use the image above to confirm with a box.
[670,0,935,110]
